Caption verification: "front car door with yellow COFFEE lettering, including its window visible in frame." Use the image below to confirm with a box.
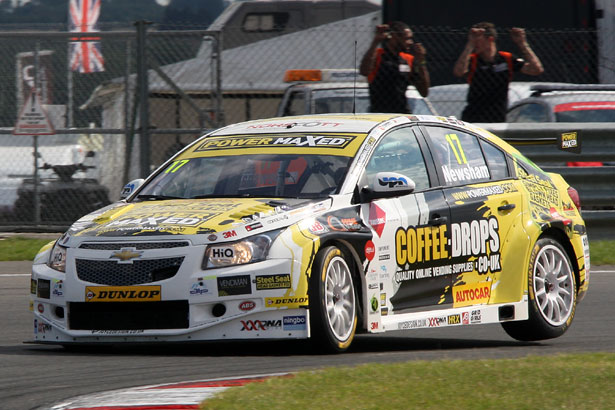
[361,126,452,323]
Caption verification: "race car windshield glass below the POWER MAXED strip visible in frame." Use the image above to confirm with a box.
[137,154,352,200]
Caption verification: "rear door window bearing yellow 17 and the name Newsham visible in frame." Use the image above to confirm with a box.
[425,127,491,186]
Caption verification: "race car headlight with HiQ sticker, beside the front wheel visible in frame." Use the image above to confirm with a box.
[201,231,280,269]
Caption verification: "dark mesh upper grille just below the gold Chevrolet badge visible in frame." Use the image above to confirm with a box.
[75,256,184,286]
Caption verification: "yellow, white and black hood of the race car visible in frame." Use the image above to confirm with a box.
[69,198,331,240]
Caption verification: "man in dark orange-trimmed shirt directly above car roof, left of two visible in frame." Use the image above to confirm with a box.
[360,21,430,114]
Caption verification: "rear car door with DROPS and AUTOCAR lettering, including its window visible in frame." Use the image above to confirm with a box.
[422,125,527,307]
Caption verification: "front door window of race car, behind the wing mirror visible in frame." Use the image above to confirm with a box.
[365,128,429,191]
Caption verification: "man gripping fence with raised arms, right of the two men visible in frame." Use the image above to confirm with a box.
[453,22,544,122]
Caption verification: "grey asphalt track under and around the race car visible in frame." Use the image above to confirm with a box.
[0,262,615,410]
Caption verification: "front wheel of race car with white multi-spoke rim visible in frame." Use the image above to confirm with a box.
[309,246,357,353]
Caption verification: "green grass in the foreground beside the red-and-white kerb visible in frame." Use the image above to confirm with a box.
[201,353,615,410]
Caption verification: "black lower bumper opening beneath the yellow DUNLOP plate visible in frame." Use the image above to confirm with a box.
[68,300,189,330]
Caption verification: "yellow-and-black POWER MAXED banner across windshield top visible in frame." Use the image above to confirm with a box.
[194,134,354,152]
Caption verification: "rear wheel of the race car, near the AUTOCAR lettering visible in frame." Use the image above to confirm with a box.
[502,238,577,341]
